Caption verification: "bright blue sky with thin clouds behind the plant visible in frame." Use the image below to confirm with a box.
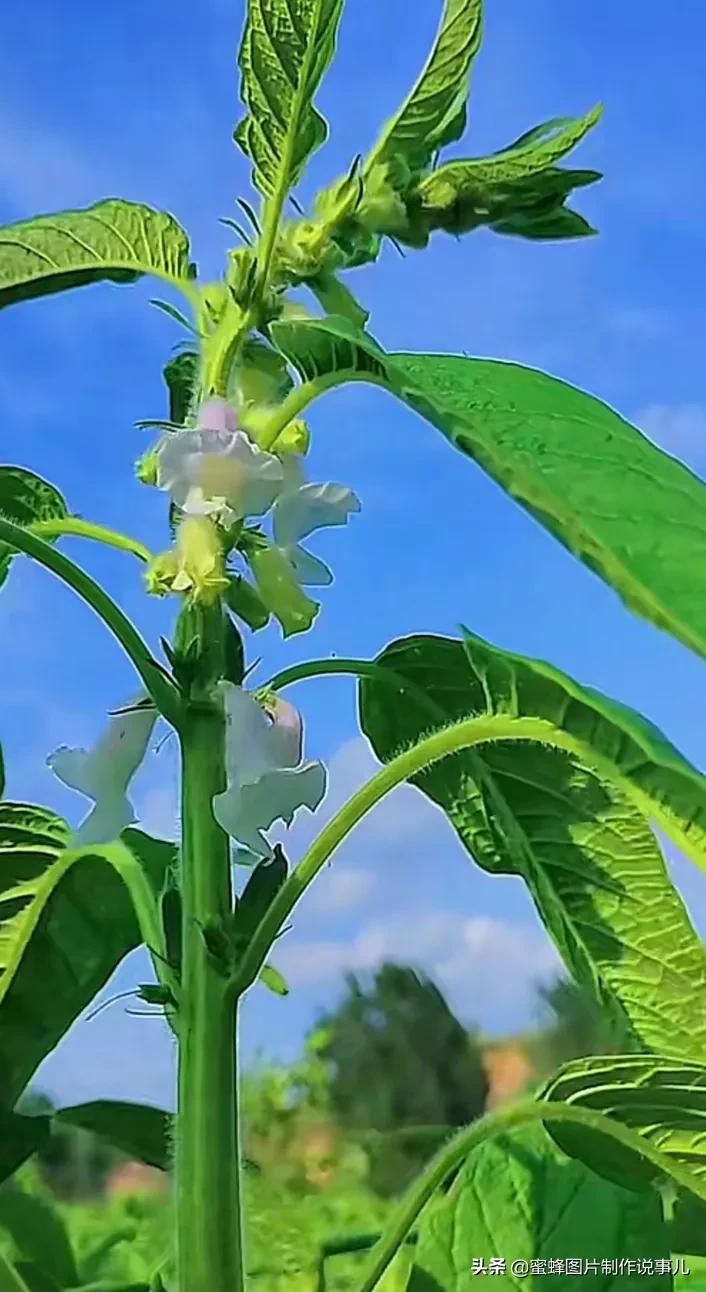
[0,0,706,1101]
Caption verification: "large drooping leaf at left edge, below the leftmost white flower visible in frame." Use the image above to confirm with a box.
[0,804,175,1109]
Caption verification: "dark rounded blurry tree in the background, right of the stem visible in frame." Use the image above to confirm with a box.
[314,964,487,1196]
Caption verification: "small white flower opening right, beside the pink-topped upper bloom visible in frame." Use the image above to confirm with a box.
[272,459,361,588]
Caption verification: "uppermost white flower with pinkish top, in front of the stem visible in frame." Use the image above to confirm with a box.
[156,399,283,525]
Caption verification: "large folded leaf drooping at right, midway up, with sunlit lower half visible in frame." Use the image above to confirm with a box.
[359,634,706,1059]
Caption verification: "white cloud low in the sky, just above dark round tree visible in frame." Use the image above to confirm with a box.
[275,910,560,1026]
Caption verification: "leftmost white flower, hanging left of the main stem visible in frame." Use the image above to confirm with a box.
[47,696,156,848]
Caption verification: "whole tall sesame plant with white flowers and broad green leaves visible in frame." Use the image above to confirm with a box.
[0,0,706,1292]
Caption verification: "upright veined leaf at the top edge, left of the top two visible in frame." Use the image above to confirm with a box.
[235,0,343,198]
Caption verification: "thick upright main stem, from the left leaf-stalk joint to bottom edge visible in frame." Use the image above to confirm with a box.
[176,703,244,1292]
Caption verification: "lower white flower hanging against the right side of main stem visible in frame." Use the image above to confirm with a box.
[213,682,326,862]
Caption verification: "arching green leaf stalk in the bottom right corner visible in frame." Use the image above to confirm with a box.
[357,1099,706,1292]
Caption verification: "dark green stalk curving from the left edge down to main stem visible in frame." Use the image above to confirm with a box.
[0,518,181,729]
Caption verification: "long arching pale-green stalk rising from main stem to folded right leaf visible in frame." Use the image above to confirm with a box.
[234,713,561,992]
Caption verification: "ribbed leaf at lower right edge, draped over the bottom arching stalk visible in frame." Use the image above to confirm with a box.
[538,1054,706,1200]
